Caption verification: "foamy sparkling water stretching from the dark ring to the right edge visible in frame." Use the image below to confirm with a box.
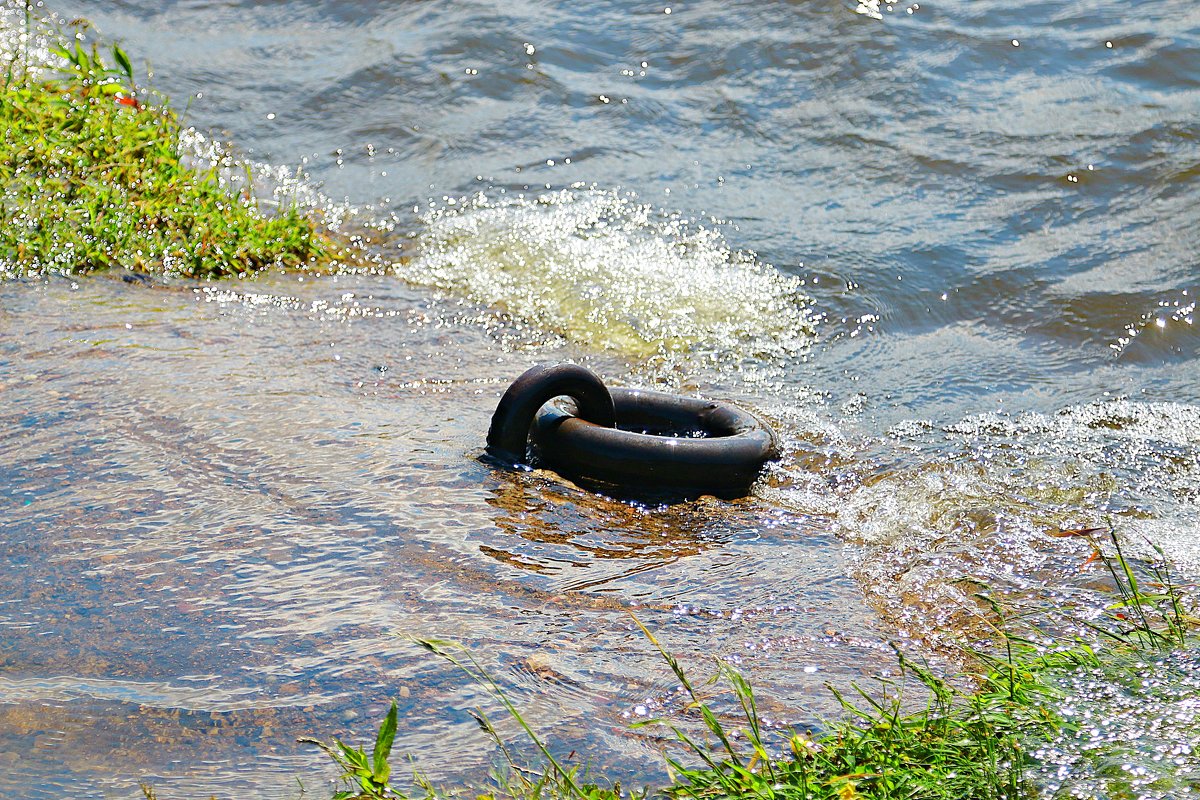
[768,399,1200,646]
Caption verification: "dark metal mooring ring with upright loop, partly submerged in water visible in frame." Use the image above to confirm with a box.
[487,365,779,497]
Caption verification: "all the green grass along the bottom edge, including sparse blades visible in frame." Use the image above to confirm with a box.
[297,525,1196,800]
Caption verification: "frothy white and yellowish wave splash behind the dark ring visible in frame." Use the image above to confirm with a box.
[396,188,815,362]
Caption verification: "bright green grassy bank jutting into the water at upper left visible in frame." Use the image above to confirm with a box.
[0,12,332,278]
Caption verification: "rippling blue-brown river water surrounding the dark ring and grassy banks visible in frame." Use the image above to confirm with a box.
[0,0,1200,799]
